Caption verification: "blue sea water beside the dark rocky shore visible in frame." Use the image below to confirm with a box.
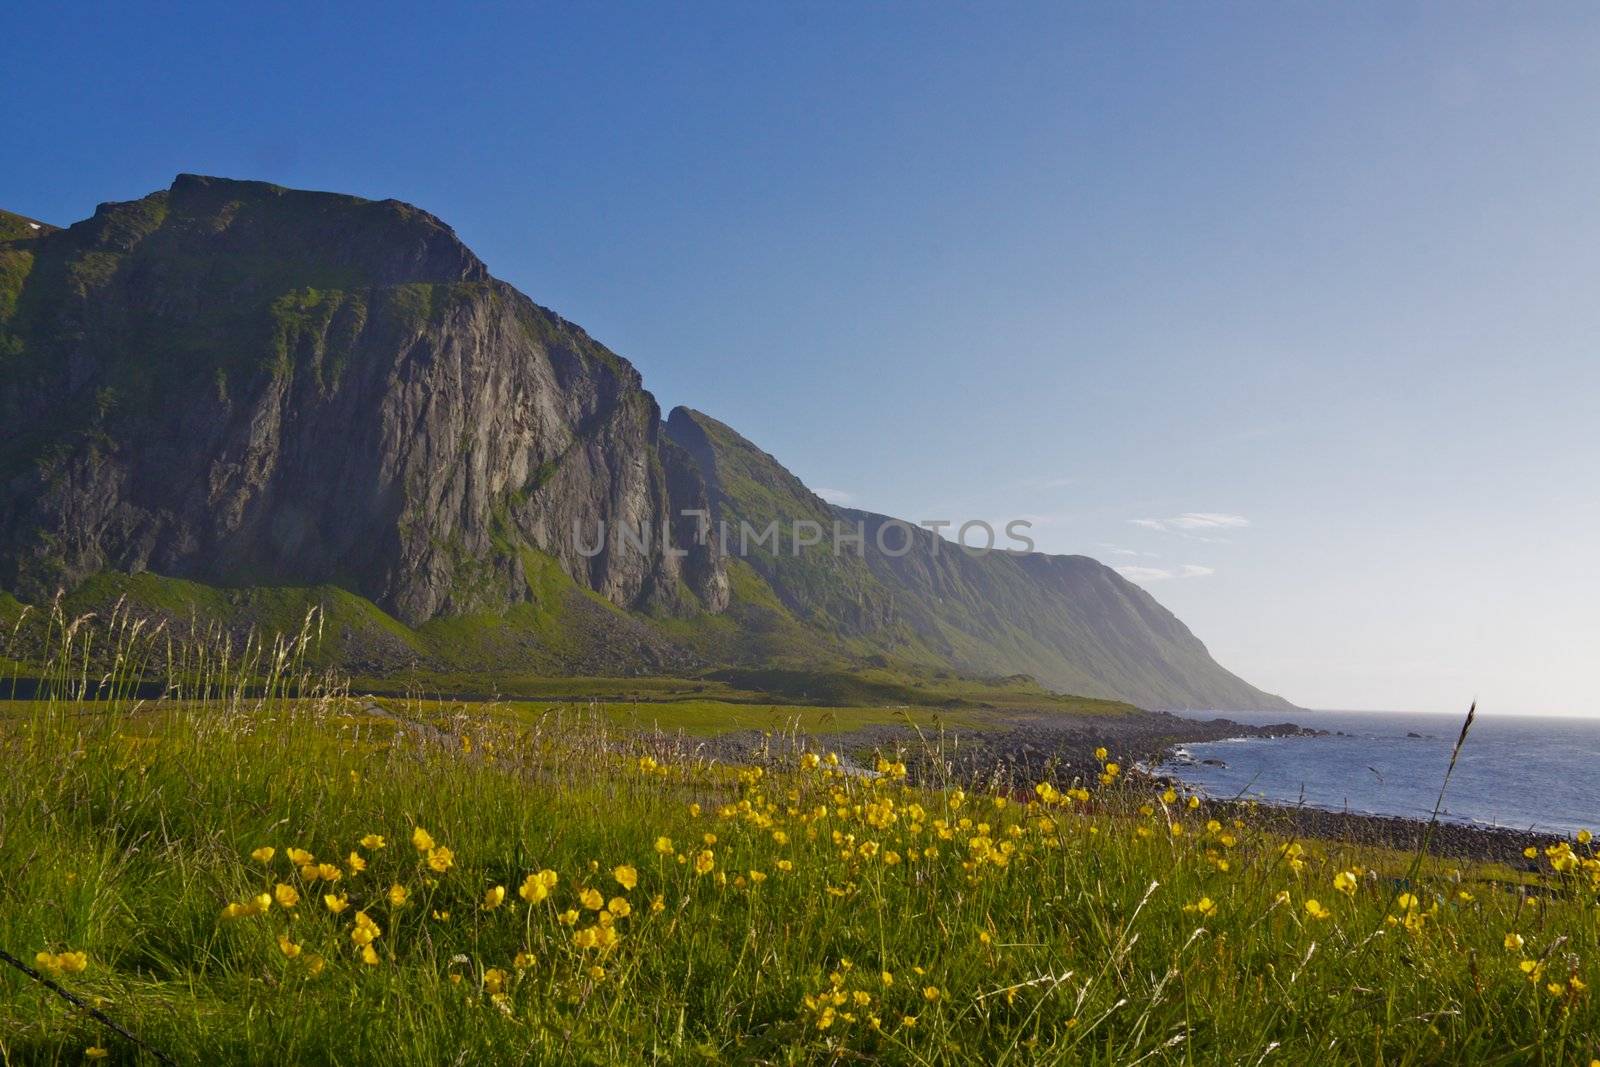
[1162,712,1600,833]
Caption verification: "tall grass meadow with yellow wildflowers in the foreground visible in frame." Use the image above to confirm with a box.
[0,604,1600,1065]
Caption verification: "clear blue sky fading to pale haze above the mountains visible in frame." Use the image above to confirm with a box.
[0,3,1600,713]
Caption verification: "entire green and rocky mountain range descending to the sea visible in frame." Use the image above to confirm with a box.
[0,174,1286,709]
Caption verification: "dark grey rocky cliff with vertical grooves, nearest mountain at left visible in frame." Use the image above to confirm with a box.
[0,176,726,624]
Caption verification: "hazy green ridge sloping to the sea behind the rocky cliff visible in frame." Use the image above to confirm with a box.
[667,408,1291,709]
